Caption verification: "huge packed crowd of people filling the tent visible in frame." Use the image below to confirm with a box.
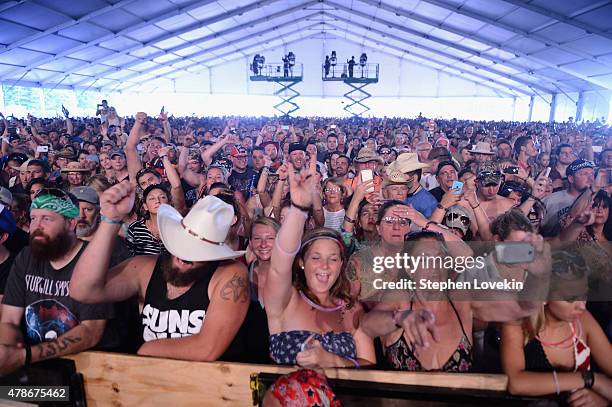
[0,101,612,407]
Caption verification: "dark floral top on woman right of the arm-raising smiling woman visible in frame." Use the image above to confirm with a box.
[386,300,472,372]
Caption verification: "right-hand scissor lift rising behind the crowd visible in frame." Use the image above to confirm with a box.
[321,64,379,117]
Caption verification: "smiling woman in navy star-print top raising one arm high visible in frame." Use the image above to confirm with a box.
[264,162,376,368]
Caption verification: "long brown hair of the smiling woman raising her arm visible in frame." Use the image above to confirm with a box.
[293,228,354,308]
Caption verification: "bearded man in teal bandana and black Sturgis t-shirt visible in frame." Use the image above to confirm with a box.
[0,188,112,376]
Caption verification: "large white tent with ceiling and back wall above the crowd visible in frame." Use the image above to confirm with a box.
[0,0,612,120]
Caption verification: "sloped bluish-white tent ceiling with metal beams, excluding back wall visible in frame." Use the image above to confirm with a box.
[0,0,612,96]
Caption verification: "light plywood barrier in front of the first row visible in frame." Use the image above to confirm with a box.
[69,352,507,407]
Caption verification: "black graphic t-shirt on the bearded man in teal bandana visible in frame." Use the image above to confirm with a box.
[2,244,113,345]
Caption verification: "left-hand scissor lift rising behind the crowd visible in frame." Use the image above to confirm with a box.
[249,64,304,117]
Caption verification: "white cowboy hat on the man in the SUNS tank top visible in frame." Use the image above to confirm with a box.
[157,195,245,261]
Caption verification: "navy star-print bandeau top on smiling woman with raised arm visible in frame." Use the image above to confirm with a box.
[270,330,357,365]
